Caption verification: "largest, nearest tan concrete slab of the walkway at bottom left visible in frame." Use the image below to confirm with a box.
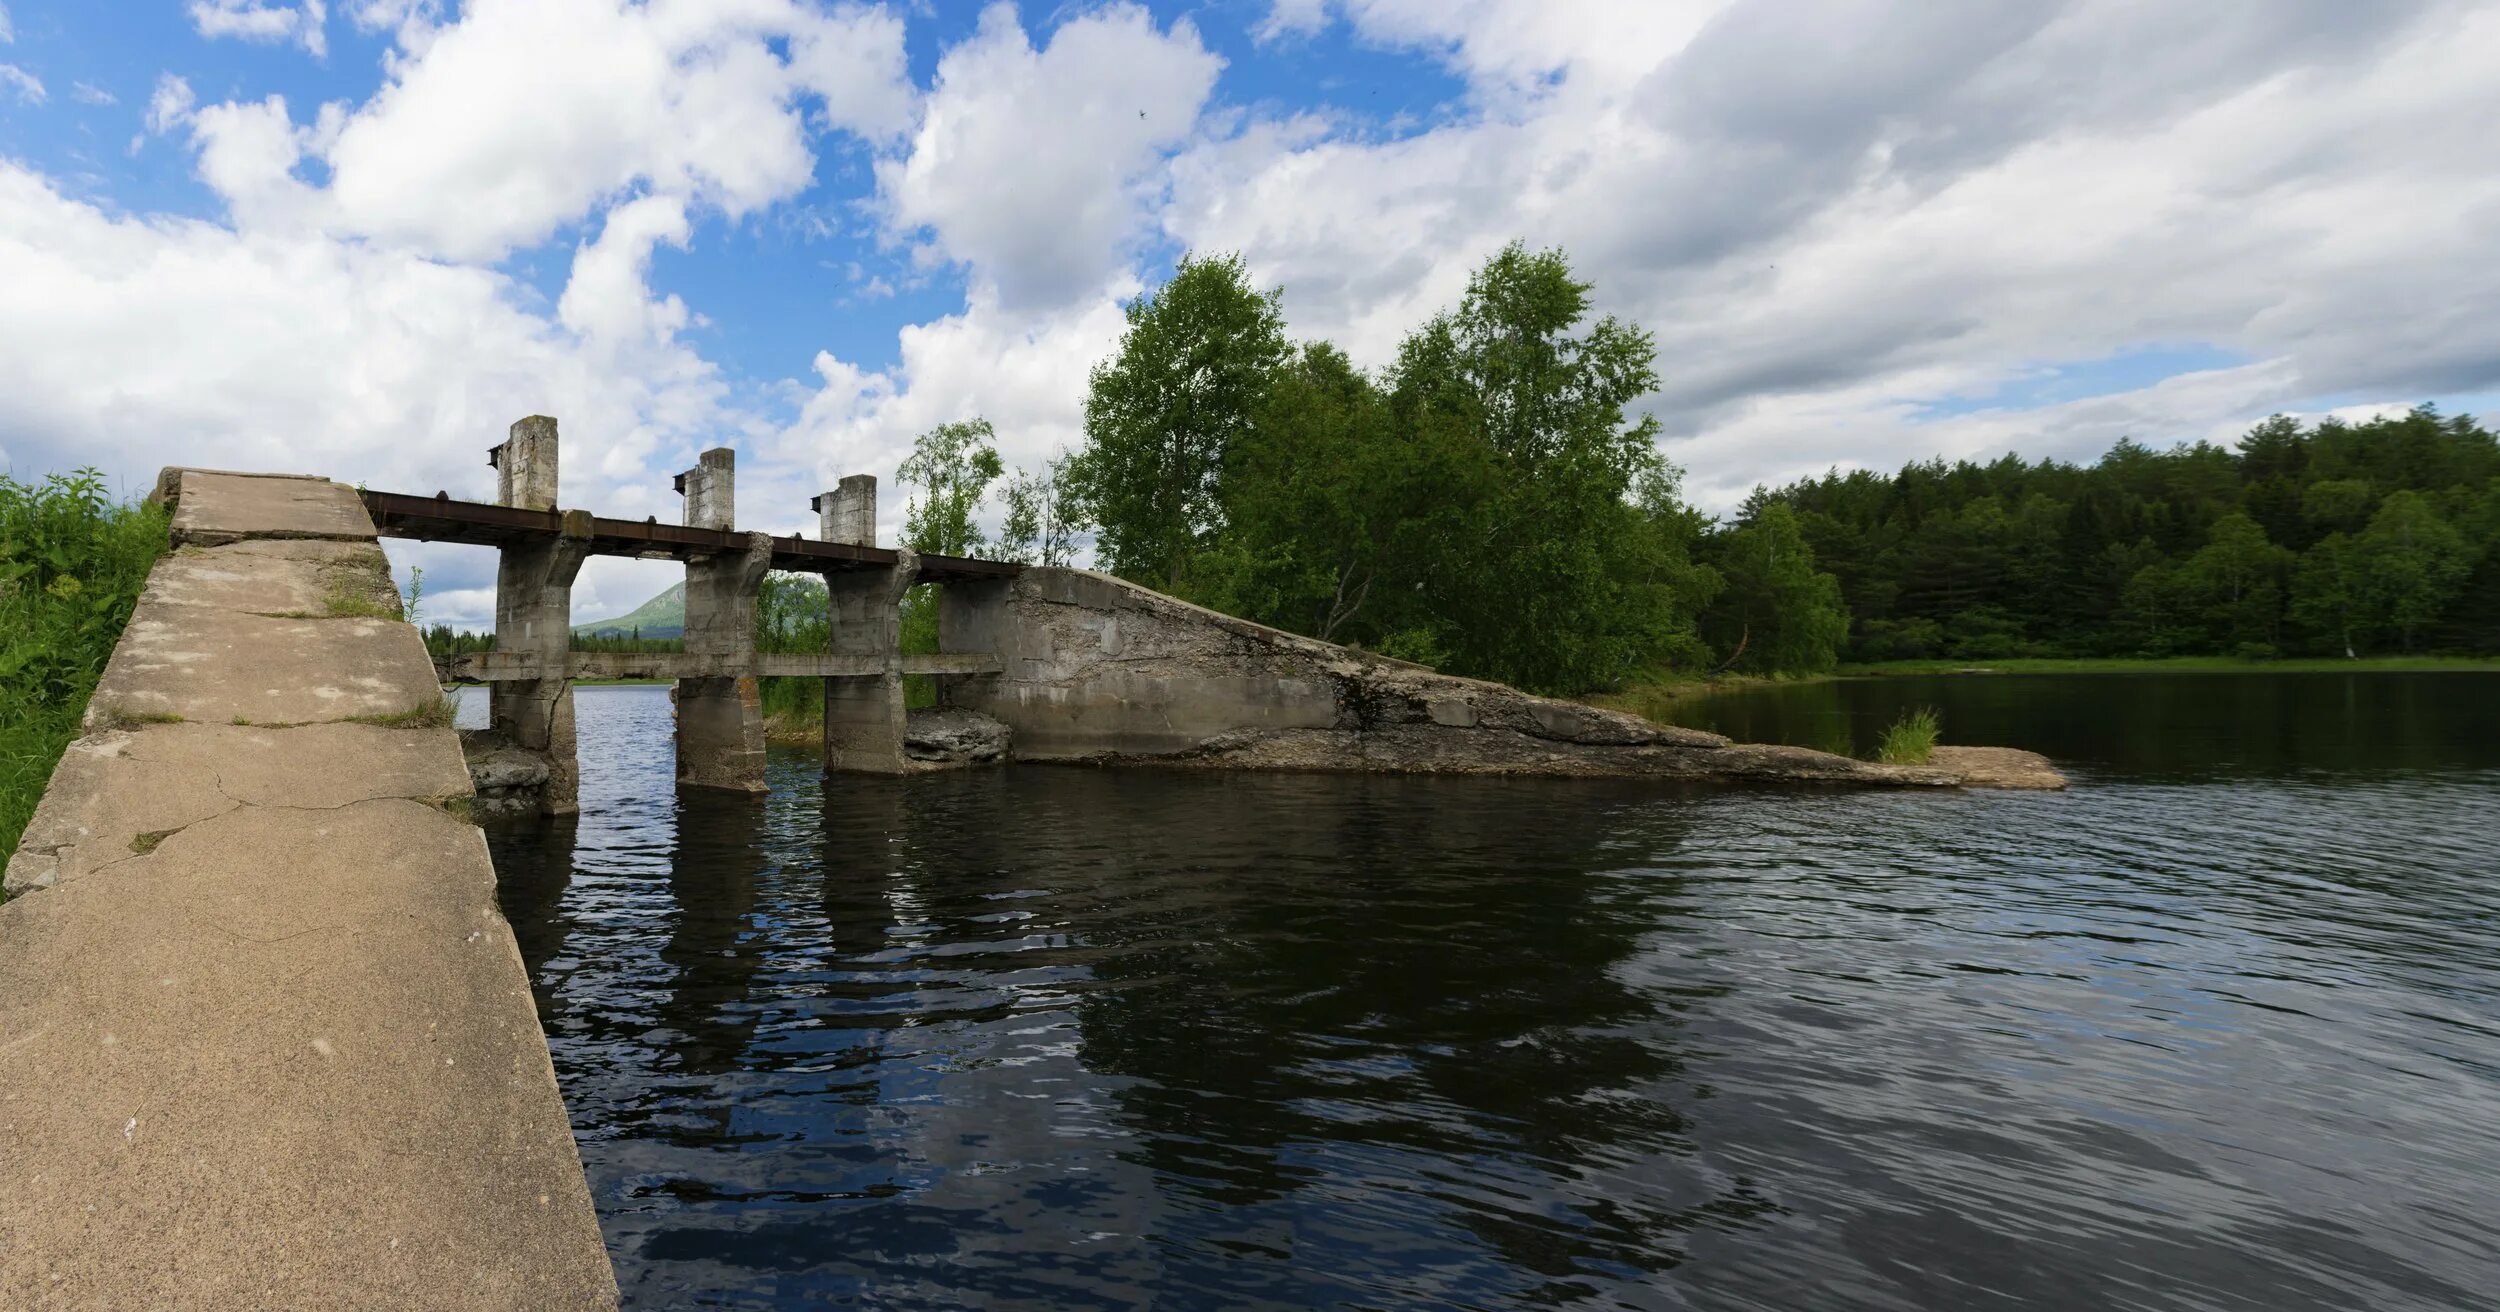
[0,800,615,1310]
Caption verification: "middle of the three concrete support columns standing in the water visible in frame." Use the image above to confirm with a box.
[678,447,773,792]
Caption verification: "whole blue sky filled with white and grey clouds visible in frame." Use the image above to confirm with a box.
[0,0,2500,625]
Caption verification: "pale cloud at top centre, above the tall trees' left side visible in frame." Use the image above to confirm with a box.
[878,5,1223,310]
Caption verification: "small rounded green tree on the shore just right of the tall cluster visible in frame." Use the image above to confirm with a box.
[1713,500,1850,675]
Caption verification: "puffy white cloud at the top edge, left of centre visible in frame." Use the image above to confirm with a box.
[301,0,910,260]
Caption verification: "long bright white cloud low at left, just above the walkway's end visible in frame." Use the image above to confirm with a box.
[0,162,740,620]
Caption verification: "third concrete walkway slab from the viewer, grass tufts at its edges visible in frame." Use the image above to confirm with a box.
[88,597,443,732]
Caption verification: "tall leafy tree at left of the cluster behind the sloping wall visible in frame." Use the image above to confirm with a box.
[1065,255,1288,590]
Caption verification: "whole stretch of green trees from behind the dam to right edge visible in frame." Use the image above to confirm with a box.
[420,242,2500,694]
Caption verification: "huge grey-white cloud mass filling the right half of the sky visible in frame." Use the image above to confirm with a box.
[1163,0,2500,505]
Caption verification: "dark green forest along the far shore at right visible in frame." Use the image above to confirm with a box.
[1760,407,2500,660]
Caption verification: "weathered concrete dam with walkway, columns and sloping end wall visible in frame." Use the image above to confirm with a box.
[0,417,2063,1310]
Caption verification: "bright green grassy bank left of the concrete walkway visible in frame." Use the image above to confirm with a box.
[0,470,165,857]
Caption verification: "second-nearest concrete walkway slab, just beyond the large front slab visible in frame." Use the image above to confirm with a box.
[8,725,470,897]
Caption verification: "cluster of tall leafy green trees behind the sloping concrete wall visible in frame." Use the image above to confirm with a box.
[1065,245,1718,692]
